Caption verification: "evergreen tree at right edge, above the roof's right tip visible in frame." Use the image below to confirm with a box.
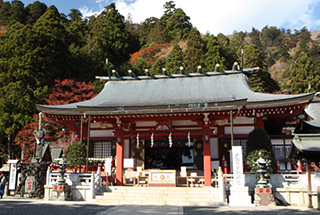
[290,52,320,94]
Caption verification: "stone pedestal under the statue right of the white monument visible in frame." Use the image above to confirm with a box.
[254,188,276,206]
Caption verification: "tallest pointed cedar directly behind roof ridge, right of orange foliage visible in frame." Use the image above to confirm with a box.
[184,28,205,73]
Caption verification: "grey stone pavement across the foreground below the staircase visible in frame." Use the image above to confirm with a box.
[0,197,320,215]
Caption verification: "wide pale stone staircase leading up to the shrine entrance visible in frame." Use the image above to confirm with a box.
[95,186,227,207]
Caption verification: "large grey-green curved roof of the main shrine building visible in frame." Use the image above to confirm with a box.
[37,72,314,115]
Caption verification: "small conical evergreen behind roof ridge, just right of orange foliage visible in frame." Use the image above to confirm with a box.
[166,43,183,74]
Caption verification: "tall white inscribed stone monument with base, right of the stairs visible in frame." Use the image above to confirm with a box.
[229,146,254,206]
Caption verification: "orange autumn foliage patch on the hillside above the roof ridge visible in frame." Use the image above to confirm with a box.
[129,43,172,66]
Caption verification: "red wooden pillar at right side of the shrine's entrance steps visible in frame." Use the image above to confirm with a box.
[203,129,211,186]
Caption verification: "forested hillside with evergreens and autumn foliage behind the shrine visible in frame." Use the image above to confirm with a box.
[0,0,320,161]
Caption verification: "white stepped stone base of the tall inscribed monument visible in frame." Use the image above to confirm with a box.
[229,186,254,206]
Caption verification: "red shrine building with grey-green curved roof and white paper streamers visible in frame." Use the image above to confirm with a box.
[37,68,314,186]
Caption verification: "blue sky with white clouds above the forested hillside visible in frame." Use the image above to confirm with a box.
[18,0,320,35]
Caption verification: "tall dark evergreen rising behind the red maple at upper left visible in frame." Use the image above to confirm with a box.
[30,6,73,86]
